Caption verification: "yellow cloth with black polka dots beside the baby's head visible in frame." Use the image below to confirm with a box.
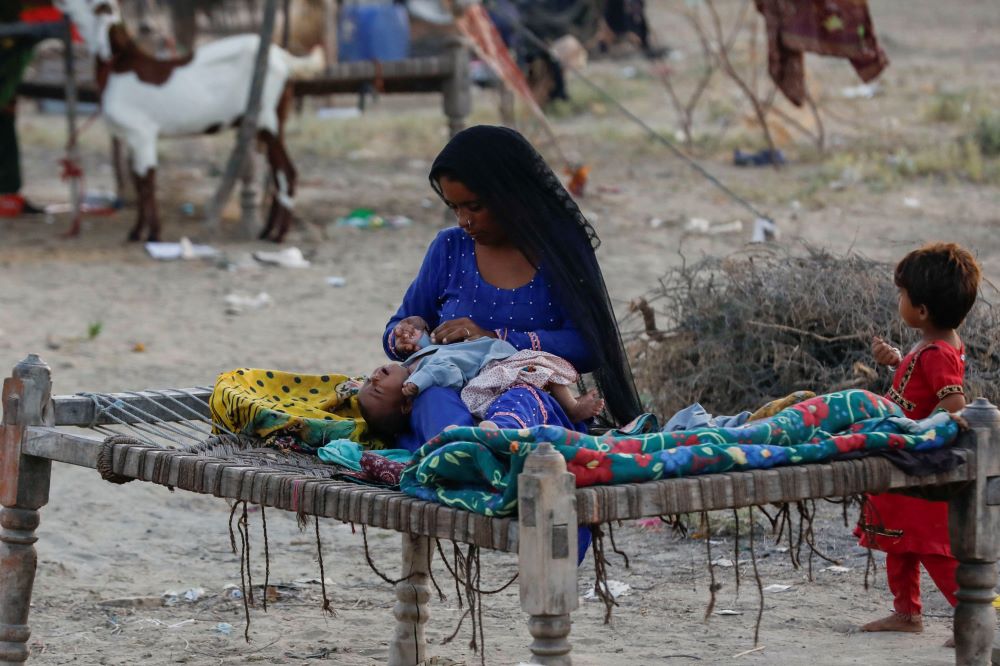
[209,368,383,453]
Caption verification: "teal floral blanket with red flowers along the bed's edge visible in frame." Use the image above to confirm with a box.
[400,390,958,516]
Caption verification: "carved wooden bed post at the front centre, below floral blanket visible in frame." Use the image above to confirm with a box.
[517,442,580,666]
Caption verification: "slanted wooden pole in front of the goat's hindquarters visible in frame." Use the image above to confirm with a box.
[205,0,278,233]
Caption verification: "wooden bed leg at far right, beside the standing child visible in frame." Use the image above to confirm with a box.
[948,398,1000,666]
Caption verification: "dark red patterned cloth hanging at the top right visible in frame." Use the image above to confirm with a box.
[754,0,889,106]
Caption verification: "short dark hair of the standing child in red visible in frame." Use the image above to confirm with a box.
[894,243,980,329]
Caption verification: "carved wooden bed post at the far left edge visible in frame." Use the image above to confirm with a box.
[0,354,55,664]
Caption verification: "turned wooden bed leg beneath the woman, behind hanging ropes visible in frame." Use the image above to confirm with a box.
[389,532,431,666]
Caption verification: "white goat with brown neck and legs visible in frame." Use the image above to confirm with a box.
[55,0,323,242]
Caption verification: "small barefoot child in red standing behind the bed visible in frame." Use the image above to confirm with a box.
[855,243,980,645]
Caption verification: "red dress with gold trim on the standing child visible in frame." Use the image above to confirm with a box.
[855,341,965,557]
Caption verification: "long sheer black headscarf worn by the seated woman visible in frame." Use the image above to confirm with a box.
[430,125,640,424]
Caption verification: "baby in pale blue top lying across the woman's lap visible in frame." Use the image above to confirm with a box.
[358,333,604,435]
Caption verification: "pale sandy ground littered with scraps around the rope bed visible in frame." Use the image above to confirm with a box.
[0,0,1000,666]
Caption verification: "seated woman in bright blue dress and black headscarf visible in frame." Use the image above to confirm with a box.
[383,125,640,449]
